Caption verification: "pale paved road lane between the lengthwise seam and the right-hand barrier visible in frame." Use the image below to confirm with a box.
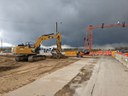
[85,57,128,96]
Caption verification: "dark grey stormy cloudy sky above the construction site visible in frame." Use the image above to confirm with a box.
[0,0,128,47]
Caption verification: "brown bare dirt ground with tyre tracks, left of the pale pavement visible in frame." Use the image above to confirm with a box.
[0,56,78,95]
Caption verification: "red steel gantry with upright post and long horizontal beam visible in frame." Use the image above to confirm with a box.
[84,21,128,51]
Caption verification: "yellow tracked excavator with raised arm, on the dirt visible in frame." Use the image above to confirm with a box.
[13,32,64,62]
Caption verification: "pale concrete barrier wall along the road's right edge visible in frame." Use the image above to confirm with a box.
[115,53,128,68]
